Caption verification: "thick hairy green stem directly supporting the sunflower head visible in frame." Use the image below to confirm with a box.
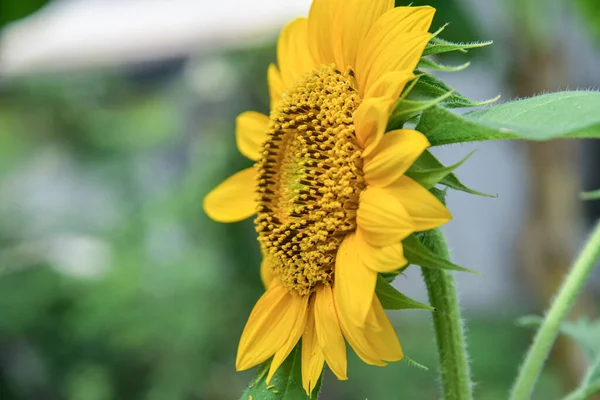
[422,229,473,400]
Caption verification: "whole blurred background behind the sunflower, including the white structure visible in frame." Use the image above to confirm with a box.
[0,0,600,400]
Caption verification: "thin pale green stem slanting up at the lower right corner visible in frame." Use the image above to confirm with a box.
[510,223,600,400]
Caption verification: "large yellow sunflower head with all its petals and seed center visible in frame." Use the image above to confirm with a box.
[204,0,451,395]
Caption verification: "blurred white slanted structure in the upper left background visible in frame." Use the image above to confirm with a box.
[0,0,311,76]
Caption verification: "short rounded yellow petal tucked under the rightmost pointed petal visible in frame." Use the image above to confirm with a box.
[356,187,415,247]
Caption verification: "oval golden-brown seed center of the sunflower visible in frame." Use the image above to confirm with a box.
[255,65,365,295]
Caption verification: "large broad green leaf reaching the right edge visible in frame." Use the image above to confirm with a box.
[416,91,600,146]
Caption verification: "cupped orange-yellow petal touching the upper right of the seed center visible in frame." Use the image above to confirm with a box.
[353,97,394,157]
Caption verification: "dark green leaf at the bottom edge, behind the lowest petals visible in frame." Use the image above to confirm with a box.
[240,342,321,400]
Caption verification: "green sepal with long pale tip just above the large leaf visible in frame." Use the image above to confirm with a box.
[408,71,500,108]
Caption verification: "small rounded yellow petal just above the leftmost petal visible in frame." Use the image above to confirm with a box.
[235,111,269,161]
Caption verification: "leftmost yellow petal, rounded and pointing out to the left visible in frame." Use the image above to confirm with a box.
[204,168,256,222]
